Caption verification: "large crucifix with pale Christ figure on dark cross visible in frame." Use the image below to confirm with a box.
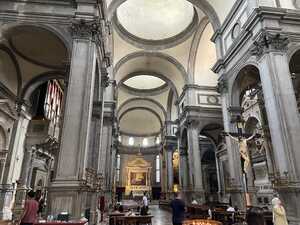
[223,108,260,205]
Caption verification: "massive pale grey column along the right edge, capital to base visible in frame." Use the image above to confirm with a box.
[252,32,300,224]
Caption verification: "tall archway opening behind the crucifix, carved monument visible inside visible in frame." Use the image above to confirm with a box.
[232,65,274,206]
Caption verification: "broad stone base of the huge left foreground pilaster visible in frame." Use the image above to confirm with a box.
[47,180,88,219]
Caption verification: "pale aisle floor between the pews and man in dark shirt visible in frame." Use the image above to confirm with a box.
[149,205,172,225]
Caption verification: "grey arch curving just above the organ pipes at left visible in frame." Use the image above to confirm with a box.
[20,71,66,101]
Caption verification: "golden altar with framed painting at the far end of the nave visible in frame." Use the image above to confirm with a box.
[125,155,152,197]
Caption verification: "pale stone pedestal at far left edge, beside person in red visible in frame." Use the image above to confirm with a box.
[0,184,14,220]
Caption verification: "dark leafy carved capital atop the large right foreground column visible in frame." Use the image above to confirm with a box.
[251,31,289,57]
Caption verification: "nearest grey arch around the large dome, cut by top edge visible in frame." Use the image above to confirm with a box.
[108,0,221,31]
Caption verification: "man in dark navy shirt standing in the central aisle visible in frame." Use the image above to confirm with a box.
[171,193,185,225]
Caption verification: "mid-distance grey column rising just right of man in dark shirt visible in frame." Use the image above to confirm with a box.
[187,120,205,204]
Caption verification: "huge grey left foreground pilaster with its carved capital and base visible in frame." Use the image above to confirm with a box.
[49,20,98,218]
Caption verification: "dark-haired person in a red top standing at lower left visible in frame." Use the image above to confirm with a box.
[20,191,39,225]
